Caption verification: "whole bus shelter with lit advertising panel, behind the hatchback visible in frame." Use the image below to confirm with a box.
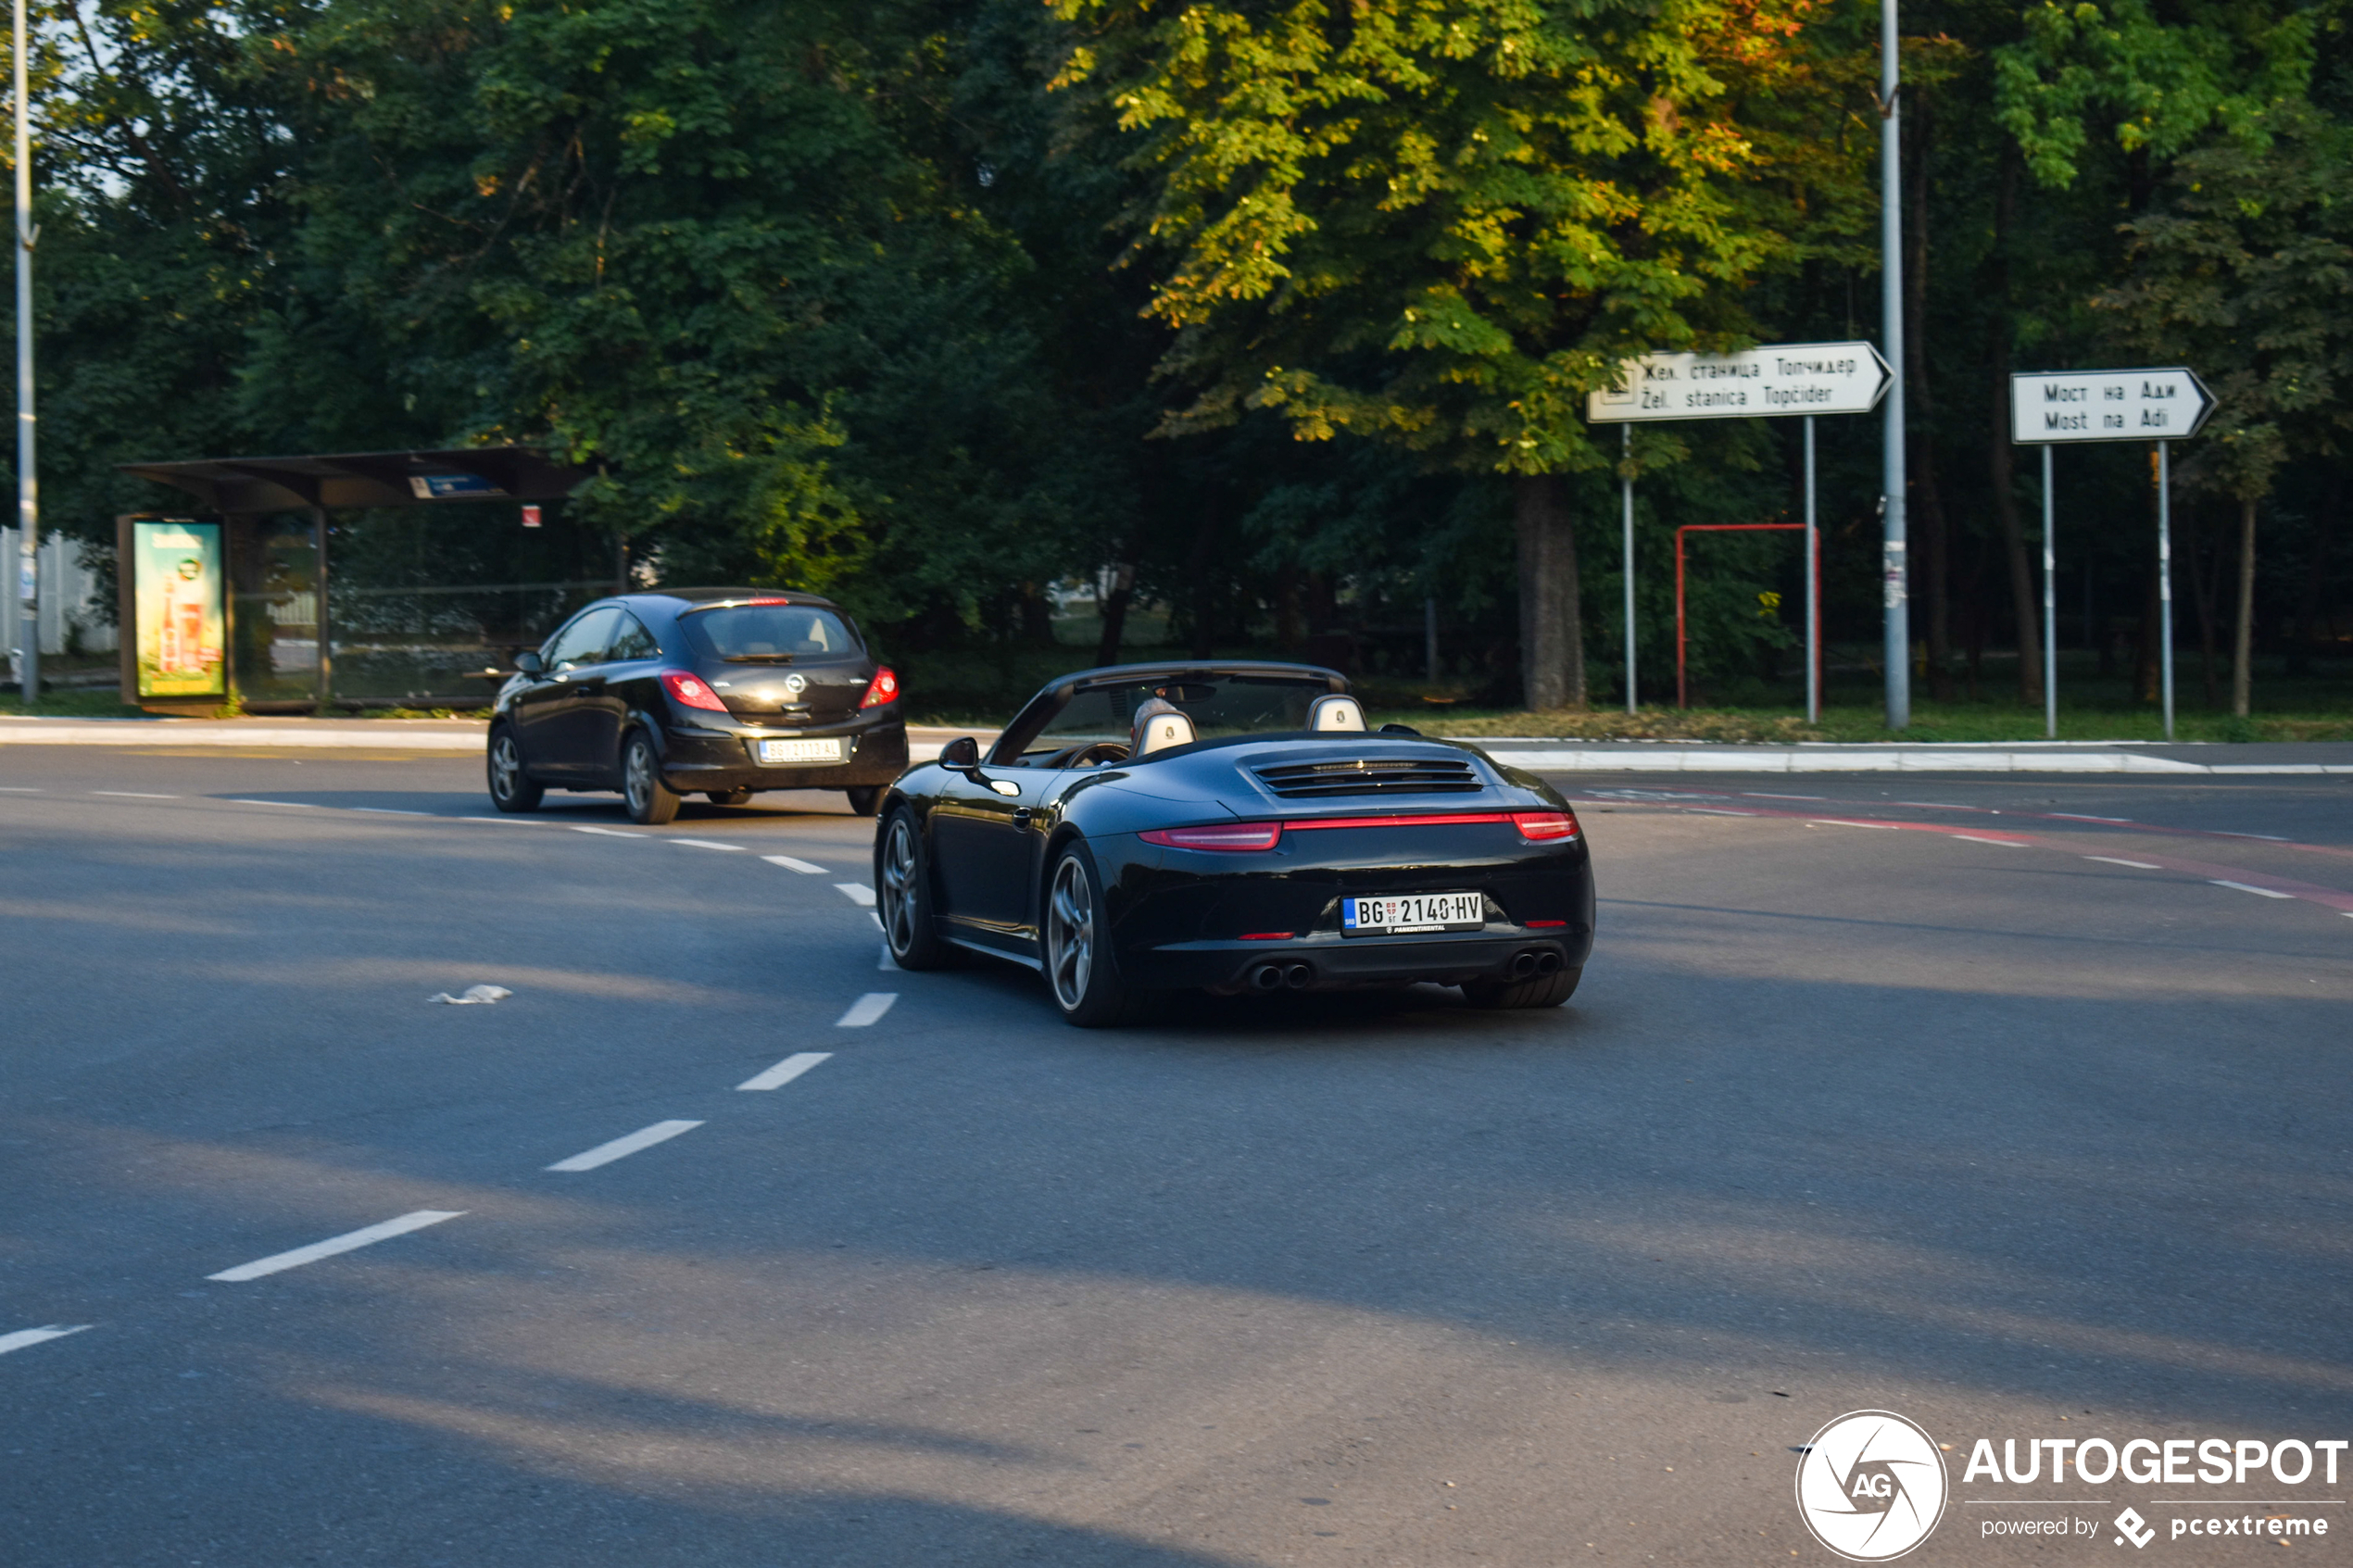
[115,446,598,712]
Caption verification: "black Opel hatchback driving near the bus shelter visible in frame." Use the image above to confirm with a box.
[489,588,906,822]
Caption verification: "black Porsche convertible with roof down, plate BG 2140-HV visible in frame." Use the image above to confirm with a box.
[875,663,1593,1025]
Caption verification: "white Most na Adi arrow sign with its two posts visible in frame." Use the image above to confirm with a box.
[2009,364,2214,741]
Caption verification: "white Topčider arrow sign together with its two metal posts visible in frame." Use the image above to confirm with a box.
[1586,344,1892,724]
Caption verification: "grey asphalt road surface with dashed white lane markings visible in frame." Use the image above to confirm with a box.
[0,747,2353,1568]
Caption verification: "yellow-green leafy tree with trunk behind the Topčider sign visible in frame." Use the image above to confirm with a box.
[1059,0,1869,705]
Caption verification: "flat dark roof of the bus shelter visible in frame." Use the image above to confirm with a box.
[120,446,588,515]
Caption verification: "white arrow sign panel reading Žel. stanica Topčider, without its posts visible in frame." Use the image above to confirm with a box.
[1586,344,1887,425]
